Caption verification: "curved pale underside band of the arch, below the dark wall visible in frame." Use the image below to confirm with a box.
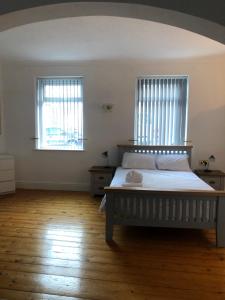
[0,2,225,44]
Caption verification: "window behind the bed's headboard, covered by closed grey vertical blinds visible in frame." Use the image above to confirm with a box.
[135,76,188,145]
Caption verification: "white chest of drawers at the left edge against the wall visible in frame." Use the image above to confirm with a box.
[0,154,15,195]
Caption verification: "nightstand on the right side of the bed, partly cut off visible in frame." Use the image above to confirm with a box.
[194,170,225,190]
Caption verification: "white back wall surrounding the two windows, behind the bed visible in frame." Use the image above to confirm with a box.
[3,57,225,190]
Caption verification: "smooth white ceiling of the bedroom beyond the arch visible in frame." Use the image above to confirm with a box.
[0,16,225,62]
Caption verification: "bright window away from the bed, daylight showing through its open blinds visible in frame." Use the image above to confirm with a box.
[36,77,83,150]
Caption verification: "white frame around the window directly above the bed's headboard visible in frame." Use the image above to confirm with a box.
[134,75,189,145]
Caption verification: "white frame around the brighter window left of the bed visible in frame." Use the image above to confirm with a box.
[34,76,85,152]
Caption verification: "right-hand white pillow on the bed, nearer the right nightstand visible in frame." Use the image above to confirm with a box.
[156,154,191,171]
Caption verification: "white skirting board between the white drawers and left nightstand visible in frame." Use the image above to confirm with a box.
[16,181,90,192]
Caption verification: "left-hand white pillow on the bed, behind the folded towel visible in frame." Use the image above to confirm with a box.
[122,152,156,170]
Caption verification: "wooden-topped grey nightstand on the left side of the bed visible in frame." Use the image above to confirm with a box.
[88,166,116,196]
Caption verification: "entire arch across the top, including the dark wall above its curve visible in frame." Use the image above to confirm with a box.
[0,0,225,44]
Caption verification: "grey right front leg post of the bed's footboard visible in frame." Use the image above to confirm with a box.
[216,197,225,247]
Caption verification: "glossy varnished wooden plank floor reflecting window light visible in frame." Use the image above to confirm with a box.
[0,190,225,300]
